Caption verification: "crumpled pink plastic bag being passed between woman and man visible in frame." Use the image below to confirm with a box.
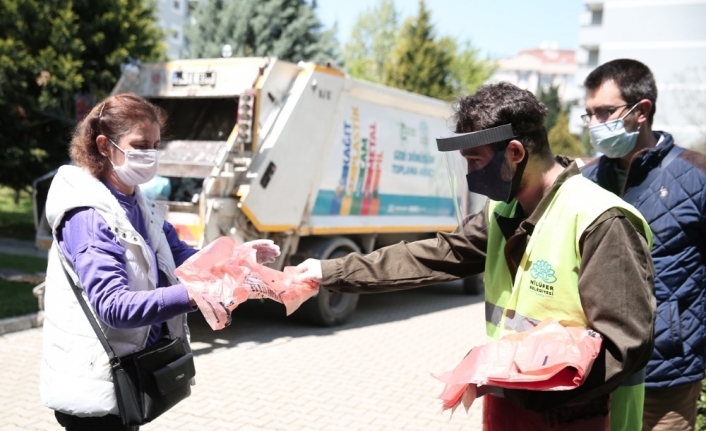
[175,237,318,330]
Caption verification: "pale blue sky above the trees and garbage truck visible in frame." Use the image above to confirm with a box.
[317,0,584,58]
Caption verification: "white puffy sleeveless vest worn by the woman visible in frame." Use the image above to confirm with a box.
[40,166,190,417]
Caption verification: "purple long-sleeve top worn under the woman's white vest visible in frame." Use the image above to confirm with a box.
[57,183,196,346]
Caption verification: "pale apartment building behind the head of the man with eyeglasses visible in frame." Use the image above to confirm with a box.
[570,0,706,150]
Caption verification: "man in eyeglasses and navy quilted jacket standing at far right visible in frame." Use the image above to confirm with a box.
[582,59,706,431]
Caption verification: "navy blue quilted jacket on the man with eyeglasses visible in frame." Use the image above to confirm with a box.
[583,132,706,388]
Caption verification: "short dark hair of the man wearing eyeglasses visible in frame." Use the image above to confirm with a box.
[583,58,657,125]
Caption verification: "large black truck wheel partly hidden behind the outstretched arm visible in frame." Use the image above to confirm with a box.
[294,238,360,326]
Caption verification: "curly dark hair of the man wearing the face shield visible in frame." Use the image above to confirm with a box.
[454,82,551,155]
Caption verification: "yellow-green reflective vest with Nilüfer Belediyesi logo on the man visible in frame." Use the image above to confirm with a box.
[485,175,652,431]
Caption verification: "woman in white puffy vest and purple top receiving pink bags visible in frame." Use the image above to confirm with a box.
[40,94,278,431]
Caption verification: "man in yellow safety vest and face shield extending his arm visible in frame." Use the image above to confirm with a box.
[298,82,655,431]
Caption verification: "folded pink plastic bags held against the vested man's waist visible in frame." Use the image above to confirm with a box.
[434,319,602,412]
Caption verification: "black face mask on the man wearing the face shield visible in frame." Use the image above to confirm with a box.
[466,146,527,203]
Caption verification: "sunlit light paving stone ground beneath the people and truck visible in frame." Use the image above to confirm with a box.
[0,283,485,431]
